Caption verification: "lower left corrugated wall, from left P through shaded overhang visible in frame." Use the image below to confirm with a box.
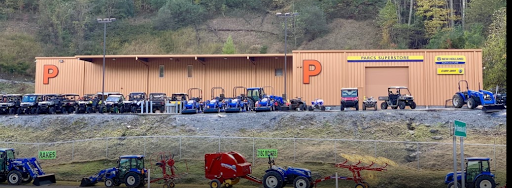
[36,57,293,99]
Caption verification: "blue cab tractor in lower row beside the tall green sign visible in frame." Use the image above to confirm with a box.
[444,157,497,188]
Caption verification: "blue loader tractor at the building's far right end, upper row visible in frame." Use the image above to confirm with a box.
[452,80,505,113]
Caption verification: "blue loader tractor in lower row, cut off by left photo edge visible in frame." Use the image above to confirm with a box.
[0,148,56,186]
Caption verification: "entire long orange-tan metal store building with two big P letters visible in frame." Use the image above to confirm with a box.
[35,49,483,106]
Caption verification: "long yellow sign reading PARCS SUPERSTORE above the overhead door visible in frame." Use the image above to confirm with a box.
[347,55,423,63]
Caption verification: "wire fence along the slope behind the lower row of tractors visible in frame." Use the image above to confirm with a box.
[0,136,507,171]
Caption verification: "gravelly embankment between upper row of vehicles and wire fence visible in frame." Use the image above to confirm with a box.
[0,110,506,144]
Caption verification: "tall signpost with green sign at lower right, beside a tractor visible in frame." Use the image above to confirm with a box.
[450,120,466,188]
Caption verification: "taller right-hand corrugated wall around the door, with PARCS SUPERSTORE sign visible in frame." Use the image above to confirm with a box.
[293,50,483,106]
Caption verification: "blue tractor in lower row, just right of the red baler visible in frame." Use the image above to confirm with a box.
[263,154,314,188]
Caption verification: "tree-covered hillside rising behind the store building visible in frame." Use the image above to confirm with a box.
[0,0,506,87]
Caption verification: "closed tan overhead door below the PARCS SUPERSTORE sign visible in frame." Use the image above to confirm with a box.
[365,67,409,109]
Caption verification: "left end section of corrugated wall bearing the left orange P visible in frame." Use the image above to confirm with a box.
[35,57,85,95]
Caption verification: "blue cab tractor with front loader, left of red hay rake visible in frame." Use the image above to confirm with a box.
[80,155,148,188]
